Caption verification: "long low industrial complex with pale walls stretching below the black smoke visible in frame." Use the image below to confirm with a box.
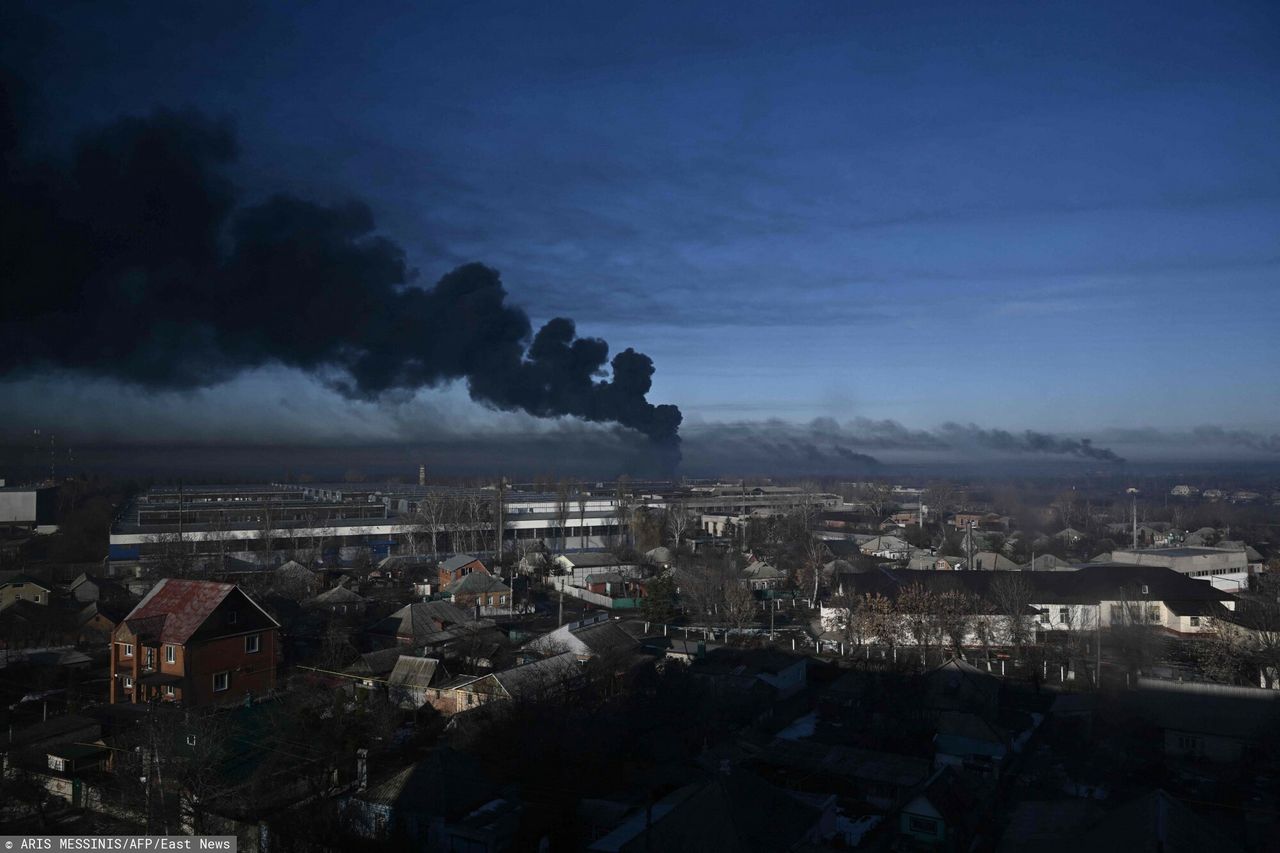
[110,473,840,565]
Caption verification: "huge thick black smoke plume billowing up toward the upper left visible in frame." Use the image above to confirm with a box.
[0,79,681,445]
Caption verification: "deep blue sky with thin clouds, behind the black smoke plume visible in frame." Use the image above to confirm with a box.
[8,1,1280,466]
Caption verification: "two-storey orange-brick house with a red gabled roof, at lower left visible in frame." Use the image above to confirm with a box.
[111,578,280,707]
